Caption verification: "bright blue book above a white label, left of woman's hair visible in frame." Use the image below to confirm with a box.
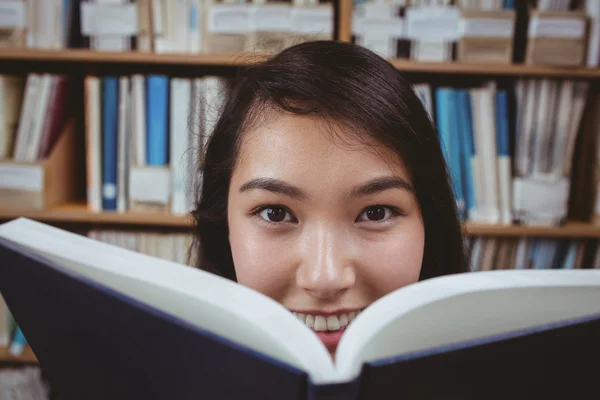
[146,75,169,166]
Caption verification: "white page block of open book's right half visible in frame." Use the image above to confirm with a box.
[336,270,600,379]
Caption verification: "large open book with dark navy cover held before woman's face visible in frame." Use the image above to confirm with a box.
[0,218,600,400]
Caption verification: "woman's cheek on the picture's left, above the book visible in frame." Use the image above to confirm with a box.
[229,216,295,301]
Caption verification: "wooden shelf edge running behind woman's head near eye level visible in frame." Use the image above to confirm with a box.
[0,203,600,239]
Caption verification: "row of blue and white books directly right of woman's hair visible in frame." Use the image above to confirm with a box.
[415,79,589,225]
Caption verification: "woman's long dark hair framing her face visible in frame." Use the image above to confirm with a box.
[192,41,467,280]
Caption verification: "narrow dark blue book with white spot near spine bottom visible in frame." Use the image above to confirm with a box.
[102,77,119,211]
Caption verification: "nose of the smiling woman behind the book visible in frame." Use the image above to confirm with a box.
[296,226,356,300]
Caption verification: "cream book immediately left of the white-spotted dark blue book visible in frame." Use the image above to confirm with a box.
[85,76,102,212]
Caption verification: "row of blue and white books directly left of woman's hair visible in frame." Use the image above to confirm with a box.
[85,75,228,214]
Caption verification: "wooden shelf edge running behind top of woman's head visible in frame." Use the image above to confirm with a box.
[0,49,600,79]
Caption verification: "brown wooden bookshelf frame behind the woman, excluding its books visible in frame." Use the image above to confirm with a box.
[0,0,600,394]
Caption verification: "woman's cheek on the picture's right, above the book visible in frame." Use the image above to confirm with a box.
[360,222,425,297]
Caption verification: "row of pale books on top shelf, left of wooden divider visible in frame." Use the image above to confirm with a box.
[0,0,334,54]
